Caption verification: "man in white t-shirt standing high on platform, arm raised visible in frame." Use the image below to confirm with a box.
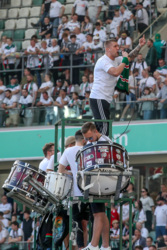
[90,37,145,135]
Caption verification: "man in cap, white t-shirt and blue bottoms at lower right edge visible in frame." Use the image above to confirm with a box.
[152,197,167,241]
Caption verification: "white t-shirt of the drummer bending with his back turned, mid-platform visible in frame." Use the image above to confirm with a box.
[59,146,82,196]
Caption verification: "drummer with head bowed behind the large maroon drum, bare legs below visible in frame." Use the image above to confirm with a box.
[81,122,112,250]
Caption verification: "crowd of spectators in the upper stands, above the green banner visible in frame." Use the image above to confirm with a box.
[0,0,167,126]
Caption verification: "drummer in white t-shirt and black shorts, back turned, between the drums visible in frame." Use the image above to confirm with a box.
[58,130,89,249]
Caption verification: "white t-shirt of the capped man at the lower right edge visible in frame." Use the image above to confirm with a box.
[154,204,167,226]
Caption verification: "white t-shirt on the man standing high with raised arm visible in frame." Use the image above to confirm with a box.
[90,55,122,103]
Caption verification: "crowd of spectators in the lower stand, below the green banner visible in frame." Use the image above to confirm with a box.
[0,183,167,250]
